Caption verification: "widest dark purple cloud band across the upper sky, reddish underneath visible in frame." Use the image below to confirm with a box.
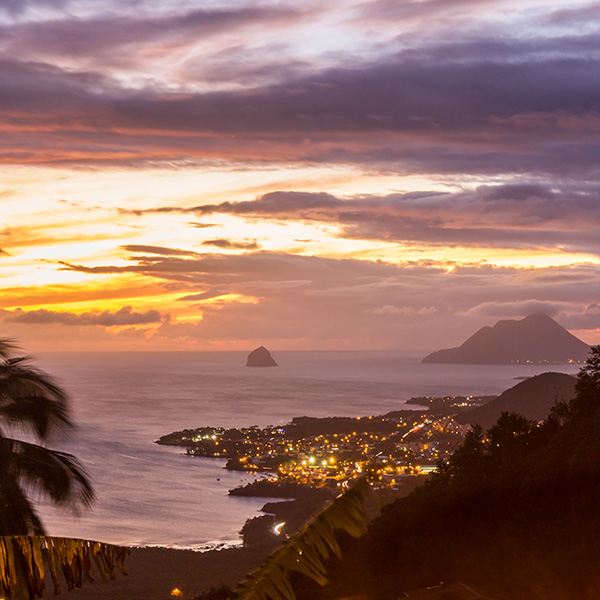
[0,26,600,176]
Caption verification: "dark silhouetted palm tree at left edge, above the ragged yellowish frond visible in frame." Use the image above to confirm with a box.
[0,339,94,536]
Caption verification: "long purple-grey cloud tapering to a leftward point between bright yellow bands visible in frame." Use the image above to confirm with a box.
[129,181,600,254]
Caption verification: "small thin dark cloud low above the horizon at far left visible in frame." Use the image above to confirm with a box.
[5,306,162,327]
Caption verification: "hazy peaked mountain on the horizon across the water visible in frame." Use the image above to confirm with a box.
[421,314,590,365]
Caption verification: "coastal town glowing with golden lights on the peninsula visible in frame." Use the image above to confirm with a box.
[157,396,493,489]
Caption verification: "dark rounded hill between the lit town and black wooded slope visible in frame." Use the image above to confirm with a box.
[455,373,577,429]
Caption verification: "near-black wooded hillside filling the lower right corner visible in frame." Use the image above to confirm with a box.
[304,346,600,600]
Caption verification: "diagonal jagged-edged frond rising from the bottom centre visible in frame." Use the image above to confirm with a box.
[236,477,369,600]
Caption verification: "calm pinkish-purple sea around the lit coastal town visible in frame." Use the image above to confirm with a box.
[29,351,578,549]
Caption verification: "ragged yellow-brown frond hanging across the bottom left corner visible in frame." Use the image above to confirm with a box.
[0,536,129,600]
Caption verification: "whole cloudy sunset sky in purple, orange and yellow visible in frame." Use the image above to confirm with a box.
[0,0,600,352]
